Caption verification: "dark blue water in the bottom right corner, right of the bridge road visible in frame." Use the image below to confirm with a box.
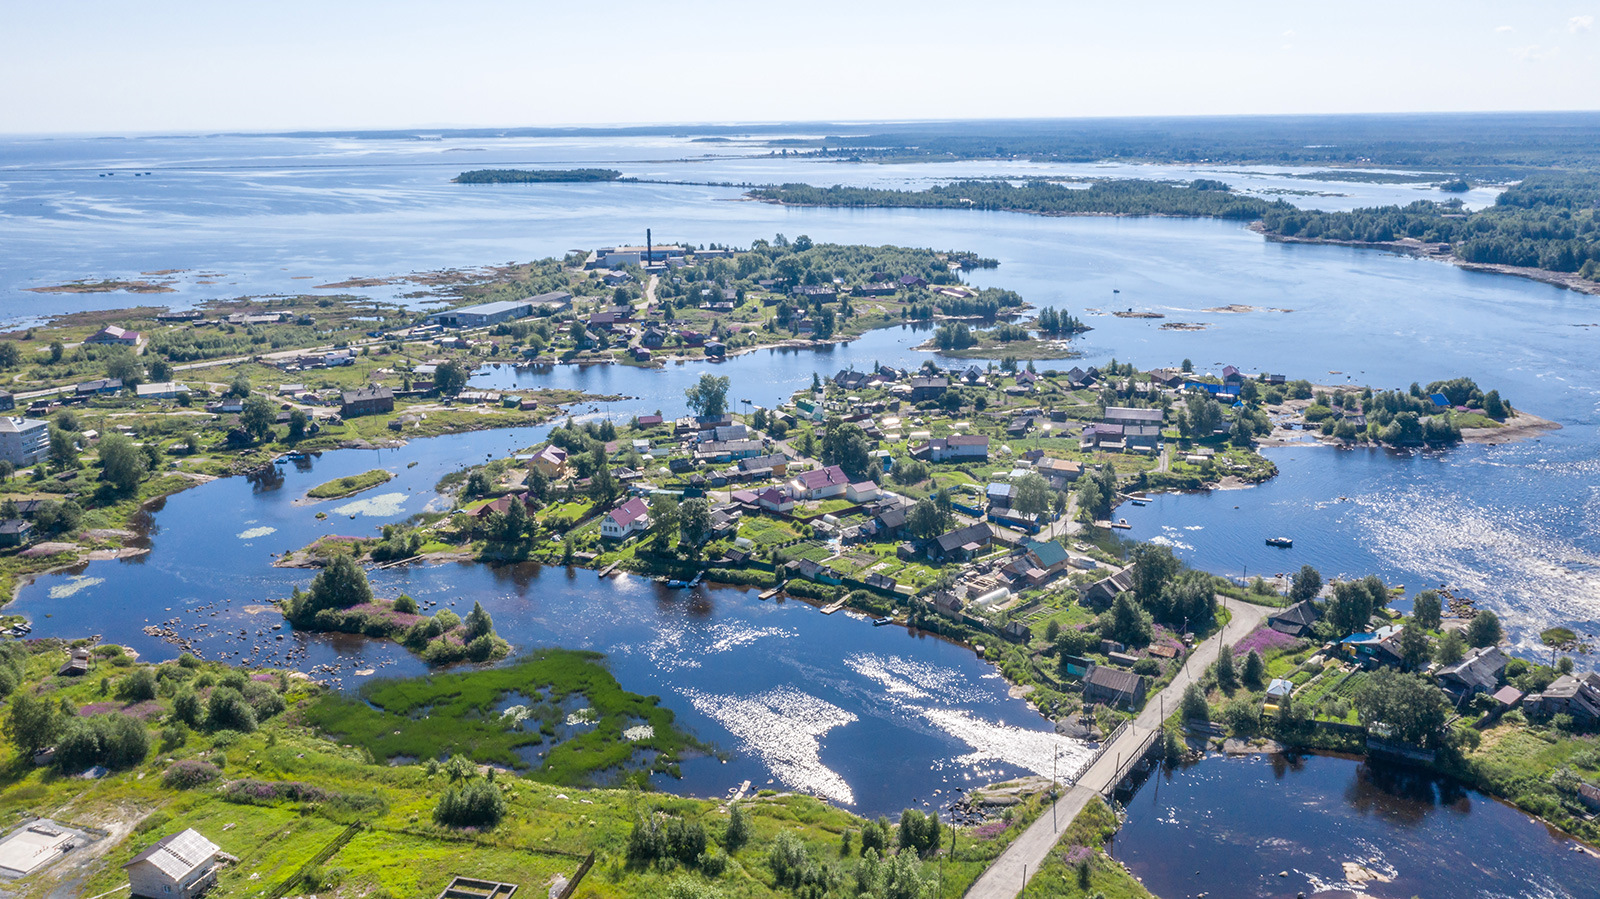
[1112,755,1600,899]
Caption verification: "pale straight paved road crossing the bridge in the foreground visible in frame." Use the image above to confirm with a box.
[966,597,1272,899]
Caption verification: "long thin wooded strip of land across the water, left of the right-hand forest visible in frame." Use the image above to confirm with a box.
[750,179,1293,221]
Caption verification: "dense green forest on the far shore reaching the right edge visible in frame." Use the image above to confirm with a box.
[1261,173,1600,280]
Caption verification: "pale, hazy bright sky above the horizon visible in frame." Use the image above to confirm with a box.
[0,0,1600,134]
